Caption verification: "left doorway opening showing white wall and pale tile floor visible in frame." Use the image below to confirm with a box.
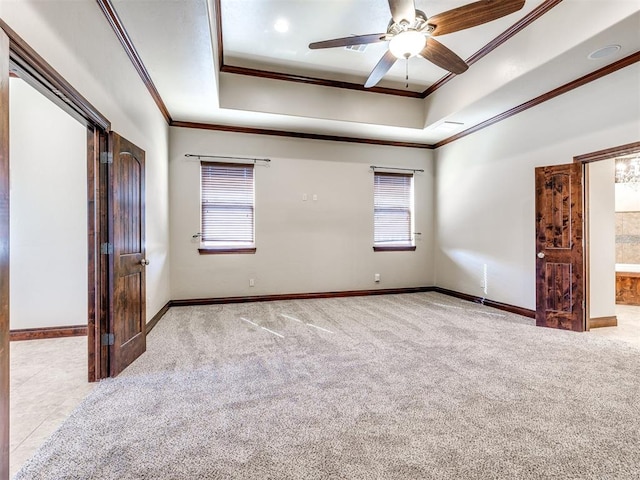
[9,76,91,475]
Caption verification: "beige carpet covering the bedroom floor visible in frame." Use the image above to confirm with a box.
[11,293,640,480]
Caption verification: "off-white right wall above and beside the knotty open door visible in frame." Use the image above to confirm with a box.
[436,64,640,309]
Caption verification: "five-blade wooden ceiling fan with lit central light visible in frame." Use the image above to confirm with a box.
[309,0,525,88]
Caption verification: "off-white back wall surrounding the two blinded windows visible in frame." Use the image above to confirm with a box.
[170,128,434,299]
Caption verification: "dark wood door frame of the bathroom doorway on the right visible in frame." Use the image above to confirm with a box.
[573,142,640,331]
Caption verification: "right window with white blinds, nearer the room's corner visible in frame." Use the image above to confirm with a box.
[373,172,416,251]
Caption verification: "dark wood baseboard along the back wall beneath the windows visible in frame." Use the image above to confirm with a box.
[170,287,434,307]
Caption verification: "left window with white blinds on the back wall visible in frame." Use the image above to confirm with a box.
[200,162,256,253]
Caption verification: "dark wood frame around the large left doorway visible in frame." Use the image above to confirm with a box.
[0,20,110,480]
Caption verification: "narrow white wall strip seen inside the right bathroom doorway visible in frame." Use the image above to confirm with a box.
[587,158,616,318]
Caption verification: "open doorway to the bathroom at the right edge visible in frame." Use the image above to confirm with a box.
[585,144,640,344]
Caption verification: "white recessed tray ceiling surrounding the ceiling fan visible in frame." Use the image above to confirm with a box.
[113,0,640,144]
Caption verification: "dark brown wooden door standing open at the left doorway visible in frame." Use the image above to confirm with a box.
[107,133,146,376]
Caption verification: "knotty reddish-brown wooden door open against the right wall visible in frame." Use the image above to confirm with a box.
[536,163,585,332]
